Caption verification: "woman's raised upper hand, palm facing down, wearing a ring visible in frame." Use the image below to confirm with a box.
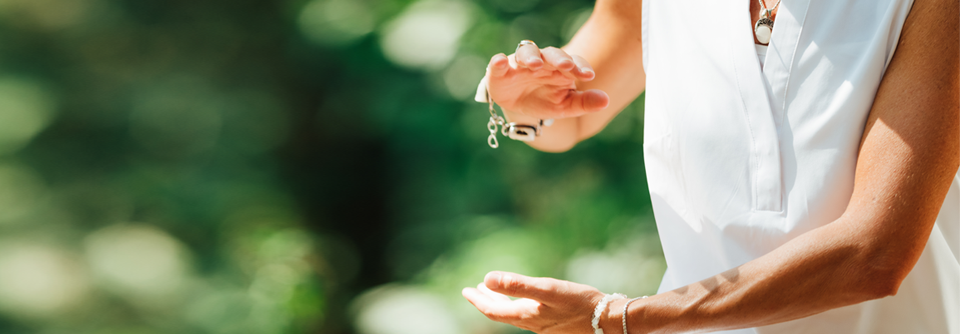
[487,44,610,119]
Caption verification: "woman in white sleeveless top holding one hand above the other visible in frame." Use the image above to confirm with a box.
[463,0,960,334]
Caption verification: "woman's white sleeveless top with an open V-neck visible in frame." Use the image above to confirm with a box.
[642,0,960,334]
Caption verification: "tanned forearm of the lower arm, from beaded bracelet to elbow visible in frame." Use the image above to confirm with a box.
[605,214,912,333]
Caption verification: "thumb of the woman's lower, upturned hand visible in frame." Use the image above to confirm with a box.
[483,271,563,304]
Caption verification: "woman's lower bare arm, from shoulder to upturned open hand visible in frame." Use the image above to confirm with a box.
[464,0,960,333]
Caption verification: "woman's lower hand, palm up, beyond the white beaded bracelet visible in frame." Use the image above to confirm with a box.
[463,271,603,334]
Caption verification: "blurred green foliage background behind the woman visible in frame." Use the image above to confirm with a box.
[0,0,665,334]
